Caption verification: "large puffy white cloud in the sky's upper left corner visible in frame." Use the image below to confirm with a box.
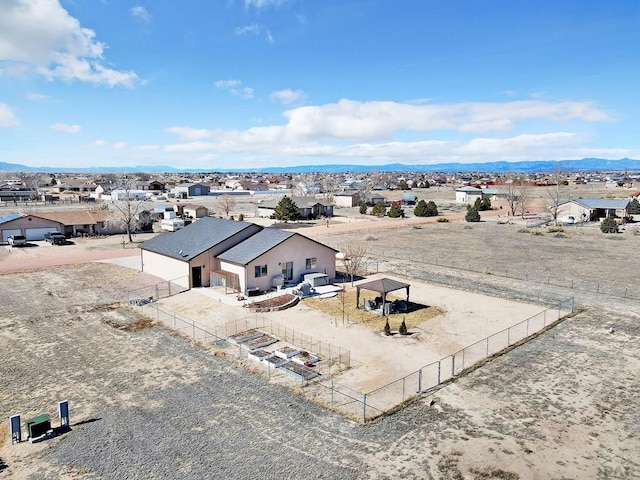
[0,0,138,87]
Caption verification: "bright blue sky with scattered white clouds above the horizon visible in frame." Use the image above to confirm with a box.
[0,0,640,170]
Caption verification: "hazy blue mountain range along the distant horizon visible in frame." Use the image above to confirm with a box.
[0,158,640,173]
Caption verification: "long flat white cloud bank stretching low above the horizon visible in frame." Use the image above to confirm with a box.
[159,97,616,164]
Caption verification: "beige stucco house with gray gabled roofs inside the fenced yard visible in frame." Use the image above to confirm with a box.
[140,217,336,293]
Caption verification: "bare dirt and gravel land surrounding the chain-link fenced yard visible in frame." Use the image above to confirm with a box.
[0,189,640,479]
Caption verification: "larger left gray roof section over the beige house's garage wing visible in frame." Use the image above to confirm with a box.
[140,217,254,262]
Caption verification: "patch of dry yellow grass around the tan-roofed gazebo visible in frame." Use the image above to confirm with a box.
[303,287,444,331]
